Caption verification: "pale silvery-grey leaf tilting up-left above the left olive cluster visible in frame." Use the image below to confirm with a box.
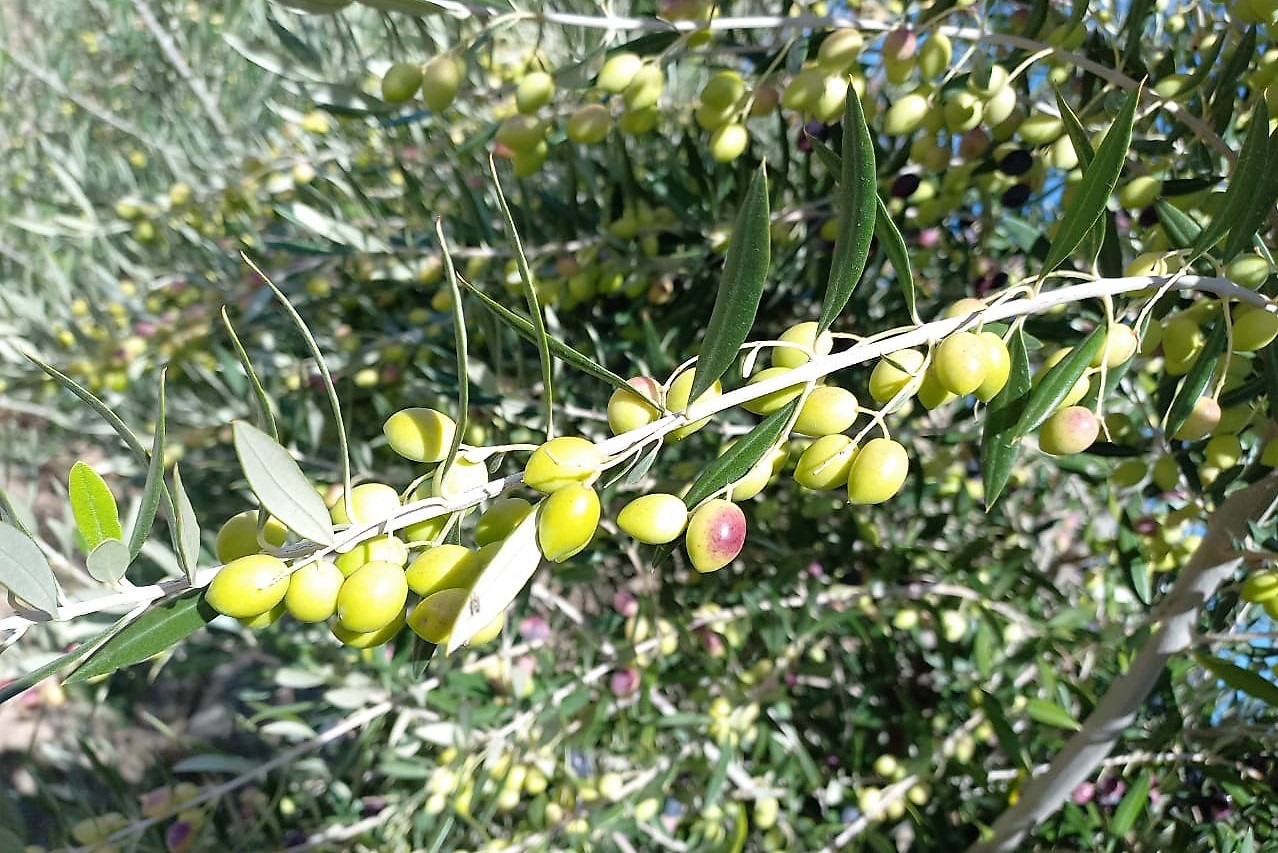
[231,421,334,545]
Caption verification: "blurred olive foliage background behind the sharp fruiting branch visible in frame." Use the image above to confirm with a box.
[0,0,1275,850]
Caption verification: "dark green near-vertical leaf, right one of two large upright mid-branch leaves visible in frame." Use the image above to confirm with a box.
[817,90,879,332]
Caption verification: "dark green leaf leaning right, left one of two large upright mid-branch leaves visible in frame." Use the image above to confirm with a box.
[688,165,772,400]
